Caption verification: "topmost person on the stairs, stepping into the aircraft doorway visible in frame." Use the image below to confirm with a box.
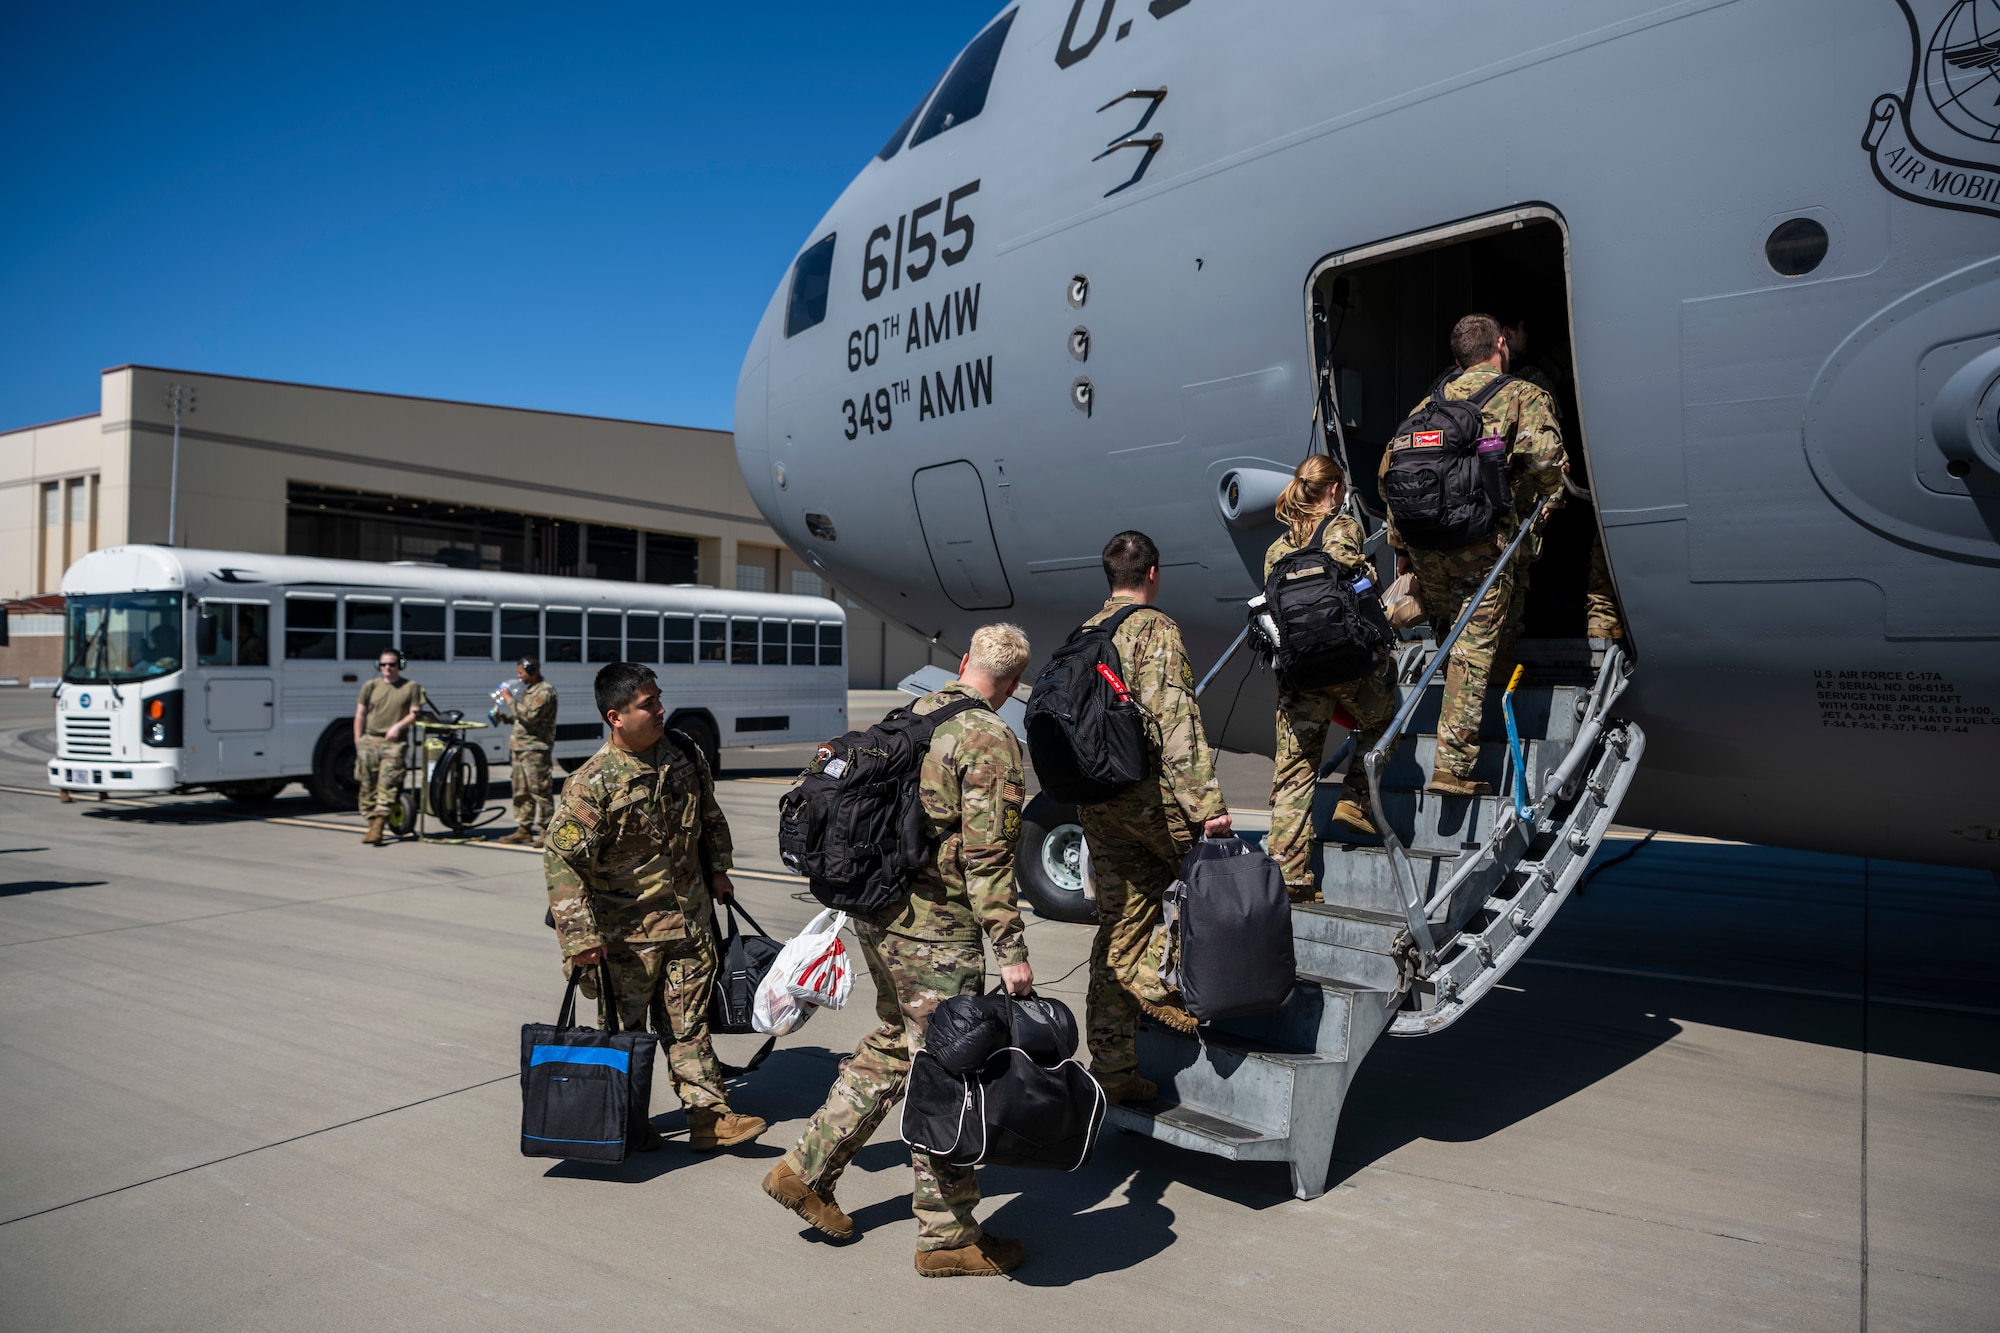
[1380,314,1570,797]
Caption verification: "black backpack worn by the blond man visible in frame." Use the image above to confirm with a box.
[778,699,988,917]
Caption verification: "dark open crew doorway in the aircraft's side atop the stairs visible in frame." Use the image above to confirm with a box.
[1306,206,1602,638]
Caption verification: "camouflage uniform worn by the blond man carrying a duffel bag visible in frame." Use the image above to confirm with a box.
[786,681,1028,1251]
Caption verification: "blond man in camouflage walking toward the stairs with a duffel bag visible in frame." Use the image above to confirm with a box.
[764,624,1034,1277]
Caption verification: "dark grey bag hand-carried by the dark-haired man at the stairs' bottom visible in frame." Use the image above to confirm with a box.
[1160,835,1298,1023]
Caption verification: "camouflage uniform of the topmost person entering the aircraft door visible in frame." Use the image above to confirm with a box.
[1378,364,1564,777]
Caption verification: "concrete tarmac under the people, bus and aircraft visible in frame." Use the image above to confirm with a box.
[0,695,2000,1331]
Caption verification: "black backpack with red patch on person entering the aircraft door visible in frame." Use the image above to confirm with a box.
[1382,370,1514,550]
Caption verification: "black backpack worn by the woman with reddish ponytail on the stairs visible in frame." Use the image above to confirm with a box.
[1264,514,1396,691]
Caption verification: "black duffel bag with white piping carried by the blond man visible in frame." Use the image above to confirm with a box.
[902,991,1104,1171]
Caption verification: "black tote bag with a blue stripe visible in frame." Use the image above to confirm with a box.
[520,967,658,1161]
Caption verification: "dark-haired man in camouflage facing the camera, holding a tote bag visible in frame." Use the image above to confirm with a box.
[542,662,764,1151]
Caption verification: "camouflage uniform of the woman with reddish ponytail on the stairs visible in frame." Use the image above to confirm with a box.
[1264,514,1396,901]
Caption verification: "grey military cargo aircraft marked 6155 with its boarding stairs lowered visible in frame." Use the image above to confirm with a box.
[736,0,2000,1195]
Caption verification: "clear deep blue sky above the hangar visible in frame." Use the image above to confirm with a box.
[0,0,1000,428]
